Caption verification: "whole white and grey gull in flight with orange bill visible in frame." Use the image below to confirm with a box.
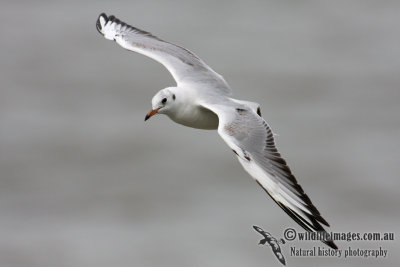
[96,13,337,249]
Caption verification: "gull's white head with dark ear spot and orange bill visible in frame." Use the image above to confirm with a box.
[144,87,176,121]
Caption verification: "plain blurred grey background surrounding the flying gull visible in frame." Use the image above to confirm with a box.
[0,0,400,267]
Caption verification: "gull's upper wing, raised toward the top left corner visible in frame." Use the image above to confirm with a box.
[96,13,231,95]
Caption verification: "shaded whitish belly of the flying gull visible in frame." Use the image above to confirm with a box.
[169,106,218,130]
